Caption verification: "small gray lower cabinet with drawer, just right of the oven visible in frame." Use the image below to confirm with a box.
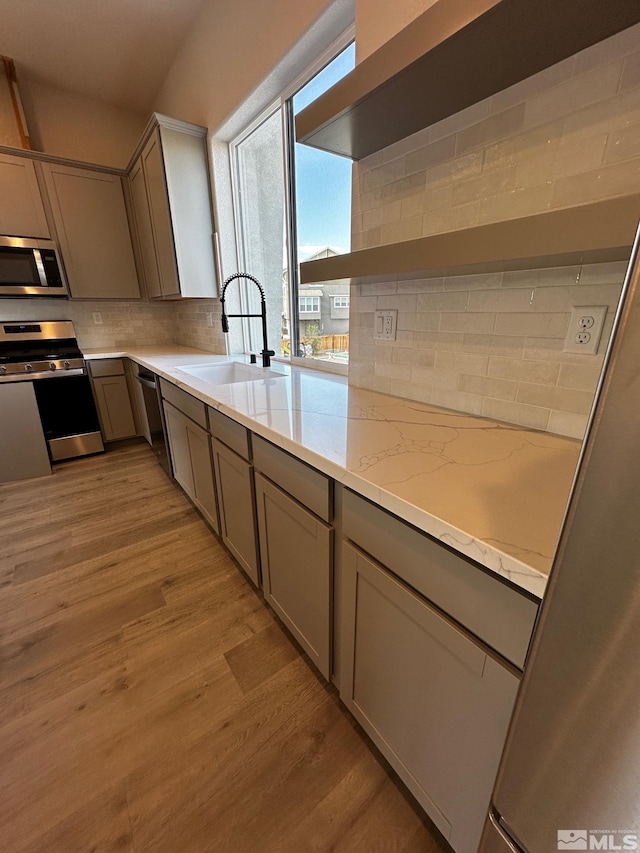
[89,358,137,441]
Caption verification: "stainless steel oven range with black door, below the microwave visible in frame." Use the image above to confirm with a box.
[0,320,104,462]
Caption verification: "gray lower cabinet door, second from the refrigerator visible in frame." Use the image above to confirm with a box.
[256,474,332,679]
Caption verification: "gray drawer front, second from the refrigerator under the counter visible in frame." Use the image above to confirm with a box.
[253,435,332,521]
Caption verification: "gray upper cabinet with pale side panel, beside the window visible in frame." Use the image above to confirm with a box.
[129,115,217,298]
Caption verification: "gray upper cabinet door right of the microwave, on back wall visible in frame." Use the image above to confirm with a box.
[43,163,140,299]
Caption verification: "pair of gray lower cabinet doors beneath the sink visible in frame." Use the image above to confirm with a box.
[164,400,219,533]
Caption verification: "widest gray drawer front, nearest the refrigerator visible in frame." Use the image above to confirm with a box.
[343,489,538,668]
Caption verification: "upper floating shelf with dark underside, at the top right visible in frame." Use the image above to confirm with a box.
[296,0,640,160]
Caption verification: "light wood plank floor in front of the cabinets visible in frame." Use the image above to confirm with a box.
[0,444,448,853]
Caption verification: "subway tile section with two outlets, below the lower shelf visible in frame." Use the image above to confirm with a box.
[349,262,626,438]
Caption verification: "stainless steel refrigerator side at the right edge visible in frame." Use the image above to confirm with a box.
[480,221,640,853]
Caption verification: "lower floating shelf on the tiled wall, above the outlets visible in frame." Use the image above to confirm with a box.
[300,194,640,284]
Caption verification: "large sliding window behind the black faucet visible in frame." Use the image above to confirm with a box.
[227,35,355,364]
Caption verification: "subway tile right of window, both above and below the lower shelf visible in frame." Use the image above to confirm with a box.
[349,25,640,438]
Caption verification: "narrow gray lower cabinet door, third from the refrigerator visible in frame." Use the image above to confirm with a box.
[212,438,260,586]
